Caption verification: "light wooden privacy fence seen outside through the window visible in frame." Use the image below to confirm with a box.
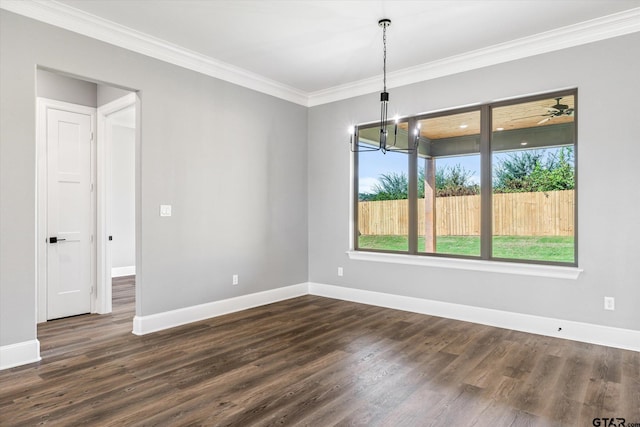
[358,190,575,236]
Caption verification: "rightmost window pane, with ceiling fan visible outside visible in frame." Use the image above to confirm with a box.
[491,95,575,264]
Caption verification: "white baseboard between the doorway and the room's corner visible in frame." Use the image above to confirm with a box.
[133,283,309,335]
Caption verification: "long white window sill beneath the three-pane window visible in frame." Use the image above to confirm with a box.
[347,250,583,280]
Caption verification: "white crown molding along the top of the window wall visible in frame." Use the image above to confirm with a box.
[308,8,640,107]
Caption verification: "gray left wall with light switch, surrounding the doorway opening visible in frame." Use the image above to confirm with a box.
[0,10,308,345]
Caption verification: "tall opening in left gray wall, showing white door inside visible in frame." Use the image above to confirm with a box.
[36,68,139,323]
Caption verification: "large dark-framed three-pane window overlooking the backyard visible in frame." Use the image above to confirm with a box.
[354,91,577,265]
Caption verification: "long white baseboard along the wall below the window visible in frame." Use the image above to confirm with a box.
[309,283,640,351]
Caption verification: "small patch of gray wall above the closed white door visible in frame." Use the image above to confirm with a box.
[37,68,98,108]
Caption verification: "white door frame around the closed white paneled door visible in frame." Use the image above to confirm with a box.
[36,97,97,323]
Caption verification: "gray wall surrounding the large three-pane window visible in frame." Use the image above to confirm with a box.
[308,33,640,330]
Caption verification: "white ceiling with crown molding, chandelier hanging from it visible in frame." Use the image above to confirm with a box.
[1,0,640,104]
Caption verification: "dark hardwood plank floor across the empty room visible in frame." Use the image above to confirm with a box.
[0,278,640,426]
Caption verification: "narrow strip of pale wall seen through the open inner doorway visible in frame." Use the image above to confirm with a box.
[111,125,136,268]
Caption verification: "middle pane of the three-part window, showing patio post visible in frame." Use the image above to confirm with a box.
[417,110,480,256]
